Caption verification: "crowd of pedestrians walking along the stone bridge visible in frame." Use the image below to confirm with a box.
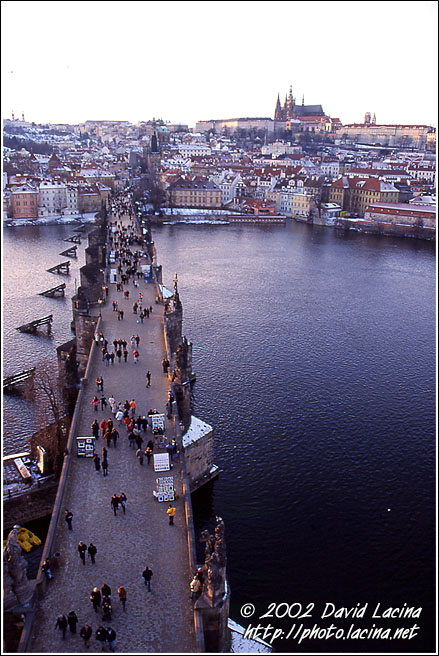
[44,198,192,651]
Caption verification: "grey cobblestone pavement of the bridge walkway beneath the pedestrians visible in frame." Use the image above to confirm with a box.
[30,218,196,653]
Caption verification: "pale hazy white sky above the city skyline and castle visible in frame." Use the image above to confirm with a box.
[2,1,438,127]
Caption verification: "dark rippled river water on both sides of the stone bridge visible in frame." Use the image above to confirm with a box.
[3,222,436,653]
